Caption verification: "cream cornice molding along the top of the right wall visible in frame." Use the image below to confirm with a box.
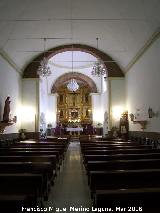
[124,29,160,73]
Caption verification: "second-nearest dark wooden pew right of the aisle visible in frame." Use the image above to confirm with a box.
[90,169,160,194]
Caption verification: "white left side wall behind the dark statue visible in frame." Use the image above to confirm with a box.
[0,56,21,134]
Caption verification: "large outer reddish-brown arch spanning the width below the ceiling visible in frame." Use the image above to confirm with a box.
[23,44,124,78]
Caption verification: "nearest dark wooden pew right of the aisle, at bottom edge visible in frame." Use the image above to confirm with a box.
[94,187,160,213]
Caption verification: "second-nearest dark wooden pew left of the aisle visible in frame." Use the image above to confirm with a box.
[0,173,43,204]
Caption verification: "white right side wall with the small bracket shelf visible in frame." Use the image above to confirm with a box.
[126,38,160,132]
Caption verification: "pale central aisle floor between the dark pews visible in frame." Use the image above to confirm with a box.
[49,142,92,212]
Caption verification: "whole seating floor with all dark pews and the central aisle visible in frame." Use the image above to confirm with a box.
[0,136,160,213]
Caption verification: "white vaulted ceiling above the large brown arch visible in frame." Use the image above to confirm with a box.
[0,0,160,71]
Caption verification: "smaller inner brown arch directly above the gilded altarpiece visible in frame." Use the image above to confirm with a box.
[51,72,97,93]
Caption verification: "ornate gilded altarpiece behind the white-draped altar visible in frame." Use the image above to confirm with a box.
[57,86,92,124]
